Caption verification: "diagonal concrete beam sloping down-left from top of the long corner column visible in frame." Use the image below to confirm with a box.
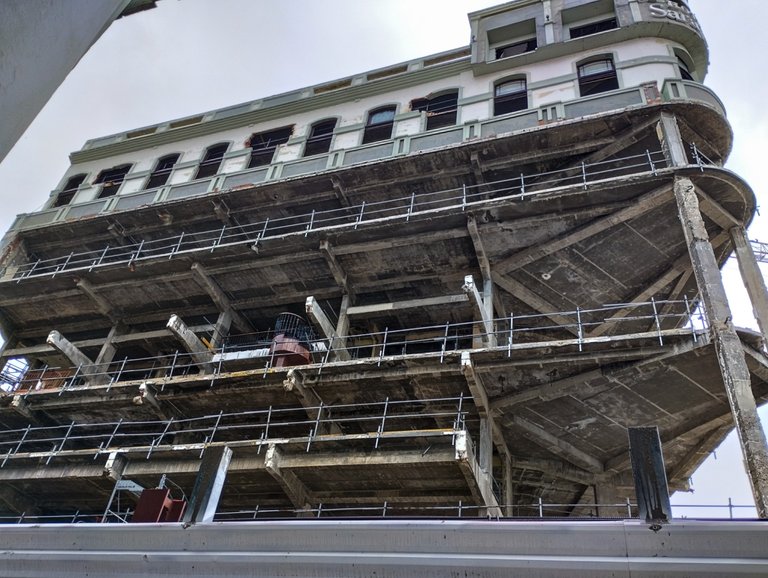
[494,185,672,274]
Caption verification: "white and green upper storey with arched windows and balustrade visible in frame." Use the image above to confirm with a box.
[3,0,716,230]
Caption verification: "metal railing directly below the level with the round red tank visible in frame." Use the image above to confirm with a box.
[0,394,471,468]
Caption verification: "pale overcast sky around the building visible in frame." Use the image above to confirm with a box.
[0,0,768,515]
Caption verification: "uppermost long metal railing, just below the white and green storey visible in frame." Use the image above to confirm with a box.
[13,151,667,282]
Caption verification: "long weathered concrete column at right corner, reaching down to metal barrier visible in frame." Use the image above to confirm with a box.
[674,177,768,518]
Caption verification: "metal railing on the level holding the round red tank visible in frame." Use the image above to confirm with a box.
[0,298,708,395]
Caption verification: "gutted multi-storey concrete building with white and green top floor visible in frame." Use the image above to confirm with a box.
[0,0,768,575]
